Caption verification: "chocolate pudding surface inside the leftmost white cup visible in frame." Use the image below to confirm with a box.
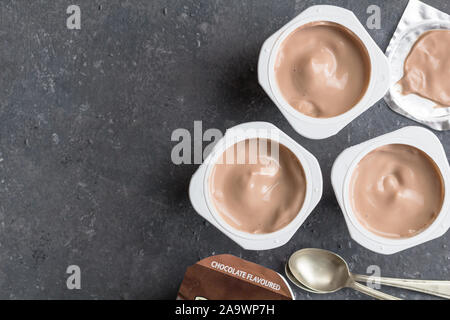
[209,138,306,234]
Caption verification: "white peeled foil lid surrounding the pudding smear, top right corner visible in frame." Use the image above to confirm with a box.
[384,0,450,130]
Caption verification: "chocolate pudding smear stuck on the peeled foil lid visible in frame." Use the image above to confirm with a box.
[399,30,450,107]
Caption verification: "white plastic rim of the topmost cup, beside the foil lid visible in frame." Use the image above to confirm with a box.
[258,5,390,139]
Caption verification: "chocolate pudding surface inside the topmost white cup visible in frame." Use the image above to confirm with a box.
[275,21,371,118]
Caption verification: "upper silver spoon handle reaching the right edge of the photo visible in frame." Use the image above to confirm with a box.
[353,274,450,299]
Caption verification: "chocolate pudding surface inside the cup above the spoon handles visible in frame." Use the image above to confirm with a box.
[350,144,444,238]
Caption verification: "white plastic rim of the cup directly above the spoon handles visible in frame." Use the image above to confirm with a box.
[331,126,450,254]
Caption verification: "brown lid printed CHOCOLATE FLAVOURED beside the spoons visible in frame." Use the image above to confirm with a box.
[178,254,293,300]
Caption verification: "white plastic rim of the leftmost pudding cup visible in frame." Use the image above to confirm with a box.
[189,122,323,250]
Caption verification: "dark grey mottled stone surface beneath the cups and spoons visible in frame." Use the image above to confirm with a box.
[0,0,450,299]
